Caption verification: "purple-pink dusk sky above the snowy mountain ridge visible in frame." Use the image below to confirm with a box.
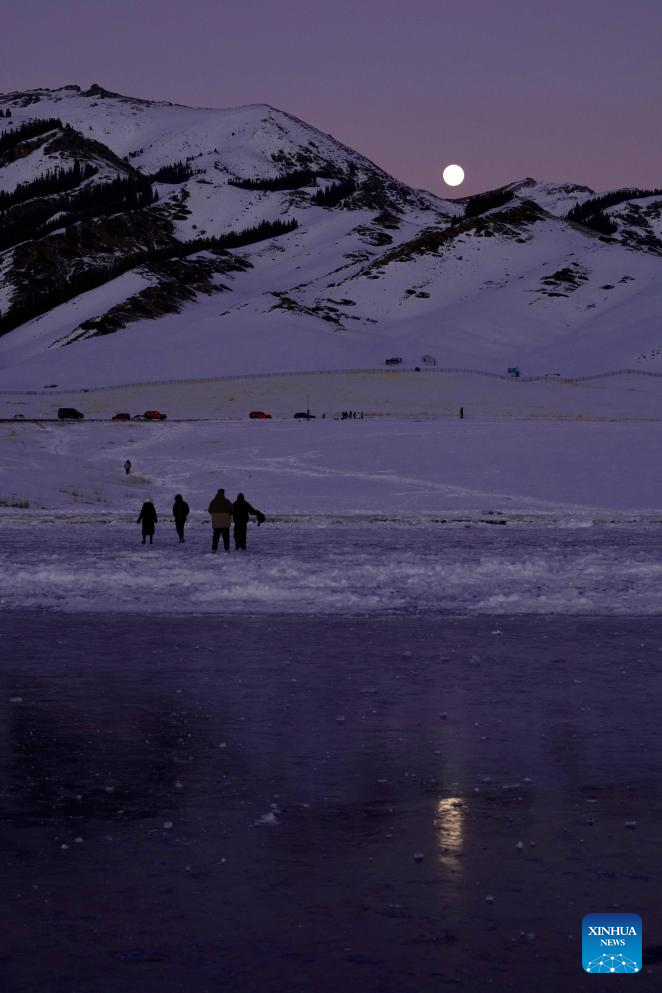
[0,0,662,195]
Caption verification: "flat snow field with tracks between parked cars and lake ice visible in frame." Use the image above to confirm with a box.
[0,414,662,524]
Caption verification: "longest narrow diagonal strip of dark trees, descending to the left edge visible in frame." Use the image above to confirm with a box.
[0,220,298,335]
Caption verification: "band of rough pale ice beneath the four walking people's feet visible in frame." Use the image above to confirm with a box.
[0,520,662,616]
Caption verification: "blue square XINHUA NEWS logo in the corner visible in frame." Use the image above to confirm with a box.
[582,914,642,973]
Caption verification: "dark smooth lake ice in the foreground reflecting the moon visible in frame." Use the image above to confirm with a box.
[0,608,662,993]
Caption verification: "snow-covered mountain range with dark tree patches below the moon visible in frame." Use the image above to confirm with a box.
[0,86,662,387]
